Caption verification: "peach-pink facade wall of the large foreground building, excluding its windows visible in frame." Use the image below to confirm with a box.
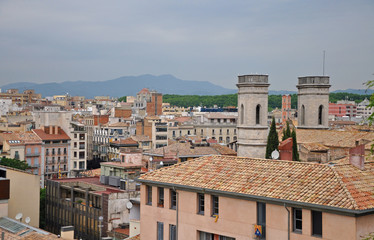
[141,185,368,240]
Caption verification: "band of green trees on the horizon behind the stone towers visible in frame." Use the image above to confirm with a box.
[163,93,370,110]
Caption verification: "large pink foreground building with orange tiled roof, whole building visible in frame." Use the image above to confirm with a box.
[139,156,374,240]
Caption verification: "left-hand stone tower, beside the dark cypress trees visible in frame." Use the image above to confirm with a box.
[236,74,270,158]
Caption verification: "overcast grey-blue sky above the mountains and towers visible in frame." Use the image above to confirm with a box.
[0,0,374,90]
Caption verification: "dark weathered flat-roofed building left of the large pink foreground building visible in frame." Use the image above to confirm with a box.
[46,174,139,240]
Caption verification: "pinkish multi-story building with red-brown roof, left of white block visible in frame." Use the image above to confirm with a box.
[32,126,71,186]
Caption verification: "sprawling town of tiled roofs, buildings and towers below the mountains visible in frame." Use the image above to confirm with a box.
[0,74,374,240]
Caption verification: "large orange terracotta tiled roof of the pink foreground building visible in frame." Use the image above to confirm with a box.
[140,156,374,210]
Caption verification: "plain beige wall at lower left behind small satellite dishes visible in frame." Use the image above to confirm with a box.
[7,169,40,227]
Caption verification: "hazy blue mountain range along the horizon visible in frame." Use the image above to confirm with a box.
[1,74,374,98]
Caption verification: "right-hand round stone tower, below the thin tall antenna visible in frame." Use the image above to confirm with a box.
[297,76,331,129]
